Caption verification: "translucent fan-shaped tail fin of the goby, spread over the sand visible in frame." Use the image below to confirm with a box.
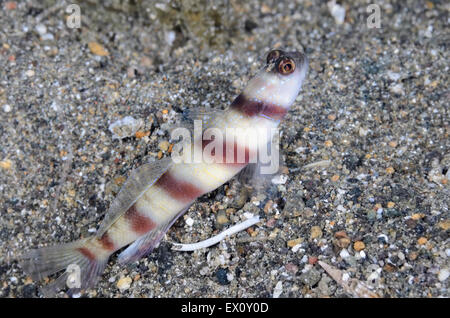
[20,238,109,297]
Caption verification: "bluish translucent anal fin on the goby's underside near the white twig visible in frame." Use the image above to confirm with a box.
[118,208,189,264]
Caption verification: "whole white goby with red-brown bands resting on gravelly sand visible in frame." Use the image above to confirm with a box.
[20,50,308,296]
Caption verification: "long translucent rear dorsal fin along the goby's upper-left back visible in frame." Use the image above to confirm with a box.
[97,158,173,237]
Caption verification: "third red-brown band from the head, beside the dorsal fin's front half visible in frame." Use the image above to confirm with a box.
[155,171,203,202]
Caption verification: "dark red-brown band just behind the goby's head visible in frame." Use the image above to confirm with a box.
[231,94,287,120]
